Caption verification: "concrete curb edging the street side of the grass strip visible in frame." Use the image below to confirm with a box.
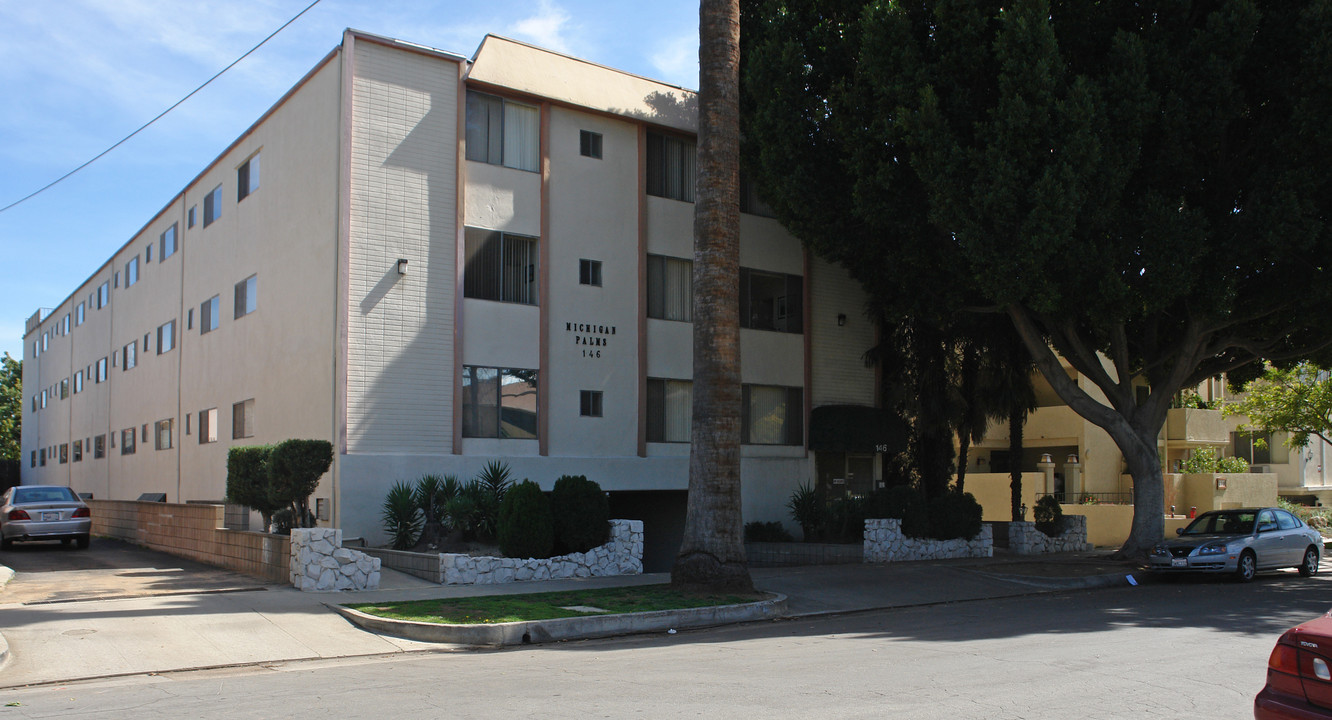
[331,592,786,645]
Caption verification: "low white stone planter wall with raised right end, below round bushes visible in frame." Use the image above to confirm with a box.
[440,520,643,586]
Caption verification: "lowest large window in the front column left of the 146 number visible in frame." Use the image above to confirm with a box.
[462,365,537,439]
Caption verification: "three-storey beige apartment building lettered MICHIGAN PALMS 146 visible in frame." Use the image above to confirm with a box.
[23,31,880,564]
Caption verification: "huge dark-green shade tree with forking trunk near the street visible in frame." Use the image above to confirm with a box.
[745,0,1332,554]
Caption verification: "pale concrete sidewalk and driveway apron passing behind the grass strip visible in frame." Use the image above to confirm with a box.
[0,554,1131,687]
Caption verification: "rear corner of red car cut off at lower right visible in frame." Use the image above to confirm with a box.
[1253,612,1332,720]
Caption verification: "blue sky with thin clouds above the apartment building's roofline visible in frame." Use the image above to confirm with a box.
[0,0,698,358]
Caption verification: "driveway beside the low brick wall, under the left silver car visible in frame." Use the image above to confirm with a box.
[0,538,265,606]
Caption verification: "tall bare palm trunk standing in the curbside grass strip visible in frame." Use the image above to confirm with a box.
[671,0,754,591]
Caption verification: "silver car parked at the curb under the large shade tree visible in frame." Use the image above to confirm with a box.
[1150,507,1323,583]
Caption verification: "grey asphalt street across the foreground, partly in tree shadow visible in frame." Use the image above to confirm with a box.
[0,574,1332,720]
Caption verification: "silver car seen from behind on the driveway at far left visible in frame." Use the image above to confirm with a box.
[0,484,92,550]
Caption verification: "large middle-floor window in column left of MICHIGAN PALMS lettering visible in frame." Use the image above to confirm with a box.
[462,228,537,305]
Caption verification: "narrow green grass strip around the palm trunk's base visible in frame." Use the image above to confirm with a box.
[346,586,769,624]
